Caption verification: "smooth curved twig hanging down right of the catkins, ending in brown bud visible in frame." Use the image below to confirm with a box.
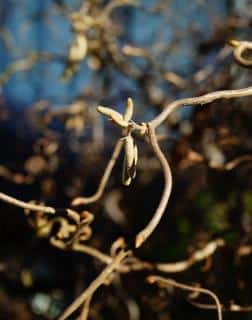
[135,124,172,248]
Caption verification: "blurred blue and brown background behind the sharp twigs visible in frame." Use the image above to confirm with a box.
[0,0,252,320]
